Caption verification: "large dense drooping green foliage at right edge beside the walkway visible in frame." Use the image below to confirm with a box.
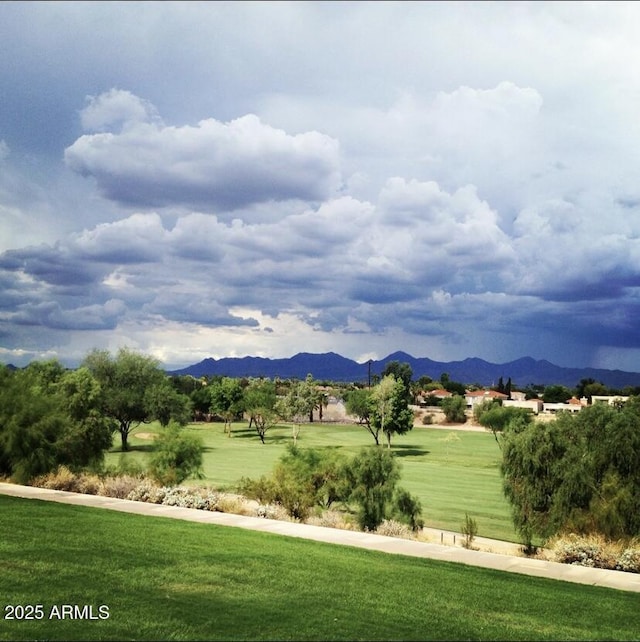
[501,398,640,545]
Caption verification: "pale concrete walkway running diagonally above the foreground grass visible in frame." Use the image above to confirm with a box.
[0,483,640,593]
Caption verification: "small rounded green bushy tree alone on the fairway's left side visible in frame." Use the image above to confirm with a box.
[149,421,204,486]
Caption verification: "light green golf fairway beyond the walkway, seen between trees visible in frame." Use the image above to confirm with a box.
[107,423,518,541]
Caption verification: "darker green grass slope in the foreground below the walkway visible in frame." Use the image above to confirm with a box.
[0,496,640,640]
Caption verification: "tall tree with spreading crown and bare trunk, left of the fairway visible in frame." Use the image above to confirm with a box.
[83,348,166,451]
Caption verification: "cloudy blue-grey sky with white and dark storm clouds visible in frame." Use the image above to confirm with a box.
[0,2,640,371]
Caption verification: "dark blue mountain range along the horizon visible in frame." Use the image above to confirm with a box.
[168,352,640,390]
